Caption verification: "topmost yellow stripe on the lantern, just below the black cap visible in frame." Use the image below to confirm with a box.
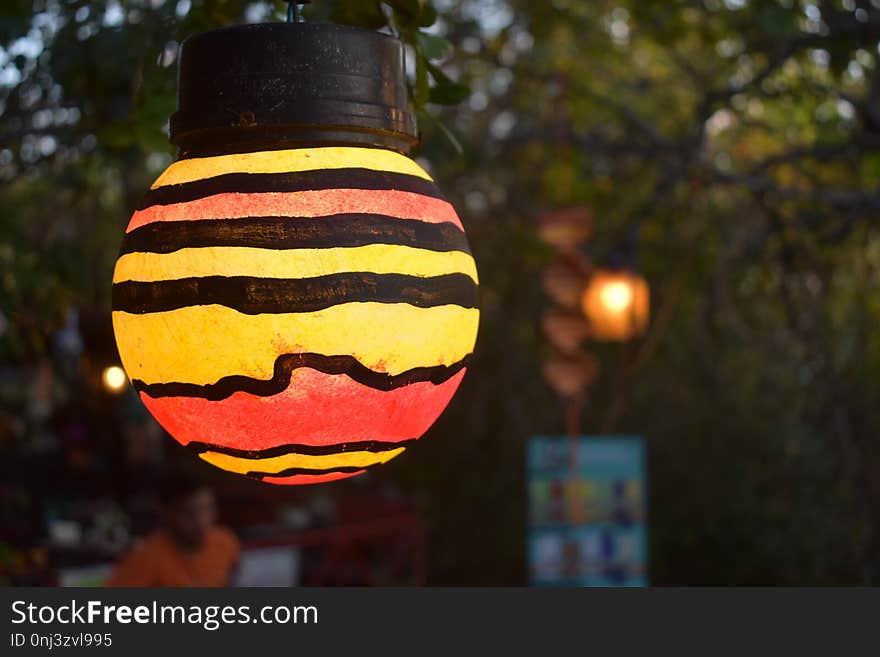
[152,146,431,189]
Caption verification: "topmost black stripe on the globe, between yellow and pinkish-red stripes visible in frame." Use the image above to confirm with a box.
[138,168,445,210]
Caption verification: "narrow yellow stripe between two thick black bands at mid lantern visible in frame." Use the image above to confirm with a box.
[113,244,477,283]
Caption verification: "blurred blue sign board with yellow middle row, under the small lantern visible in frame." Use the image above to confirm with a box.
[526,436,648,586]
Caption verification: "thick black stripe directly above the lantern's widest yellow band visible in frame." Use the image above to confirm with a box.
[113,272,478,315]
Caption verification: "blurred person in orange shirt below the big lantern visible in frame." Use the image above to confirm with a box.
[107,473,240,586]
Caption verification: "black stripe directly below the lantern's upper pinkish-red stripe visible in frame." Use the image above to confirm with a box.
[120,214,470,255]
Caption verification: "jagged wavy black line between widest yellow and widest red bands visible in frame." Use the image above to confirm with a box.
[132,353,468,401]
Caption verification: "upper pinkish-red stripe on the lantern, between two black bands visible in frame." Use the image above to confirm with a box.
[125,189,462,233]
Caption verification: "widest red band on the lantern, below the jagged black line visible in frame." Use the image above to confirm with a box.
[141,368,465,450]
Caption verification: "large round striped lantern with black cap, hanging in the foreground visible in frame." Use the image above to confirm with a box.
[113,23,479,484]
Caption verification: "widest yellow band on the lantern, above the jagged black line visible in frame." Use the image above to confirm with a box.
[113,302,479,385]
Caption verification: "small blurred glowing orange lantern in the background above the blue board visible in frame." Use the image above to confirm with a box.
[581,269,650,342]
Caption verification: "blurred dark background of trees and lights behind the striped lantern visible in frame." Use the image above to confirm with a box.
[0,0,880,585]
